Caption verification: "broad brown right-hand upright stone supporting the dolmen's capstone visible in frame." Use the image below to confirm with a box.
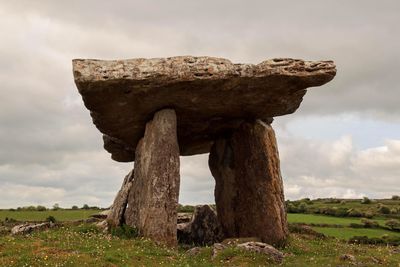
[209,120,288,245]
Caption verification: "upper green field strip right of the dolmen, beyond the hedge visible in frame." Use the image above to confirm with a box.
[288,213,385,226]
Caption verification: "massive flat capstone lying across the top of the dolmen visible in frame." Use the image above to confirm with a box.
[73,56,336,161]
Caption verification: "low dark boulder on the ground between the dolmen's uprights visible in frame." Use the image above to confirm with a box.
[177,205,222,245]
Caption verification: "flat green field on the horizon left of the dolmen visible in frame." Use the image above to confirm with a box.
[0,210,100,221]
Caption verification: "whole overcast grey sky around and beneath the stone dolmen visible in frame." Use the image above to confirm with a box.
[0,0,400,208]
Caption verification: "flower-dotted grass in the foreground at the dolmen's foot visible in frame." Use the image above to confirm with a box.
[0,226,400,267]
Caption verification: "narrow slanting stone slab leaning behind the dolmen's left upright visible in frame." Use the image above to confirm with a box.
[107,170,134,226]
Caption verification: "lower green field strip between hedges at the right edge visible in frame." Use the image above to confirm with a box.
[313,227,400,240]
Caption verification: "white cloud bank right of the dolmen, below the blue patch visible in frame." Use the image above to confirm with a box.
[278,129,400,199]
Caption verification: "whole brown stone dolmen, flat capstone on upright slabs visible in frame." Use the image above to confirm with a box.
[73,56,336,246]
